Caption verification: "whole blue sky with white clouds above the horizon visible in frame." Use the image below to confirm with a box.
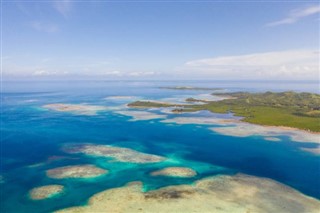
[1,0,320,80]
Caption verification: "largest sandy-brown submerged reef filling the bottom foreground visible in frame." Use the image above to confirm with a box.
[58,174,320,213]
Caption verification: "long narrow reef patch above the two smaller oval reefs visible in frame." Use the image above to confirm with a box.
[63,144,166,163]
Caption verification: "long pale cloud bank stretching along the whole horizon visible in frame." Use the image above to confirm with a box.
[2,50,320,80]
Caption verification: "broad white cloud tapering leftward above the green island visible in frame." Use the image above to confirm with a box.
[180,50,319,80]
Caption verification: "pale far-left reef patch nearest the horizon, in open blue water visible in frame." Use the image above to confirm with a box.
[43,103,107,115]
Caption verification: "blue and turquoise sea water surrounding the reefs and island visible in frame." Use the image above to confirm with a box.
[0,81,320,213]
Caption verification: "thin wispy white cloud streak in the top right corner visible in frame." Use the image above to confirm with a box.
[266,5,320,27]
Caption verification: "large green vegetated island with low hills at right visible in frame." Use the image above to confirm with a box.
[128,91,320,132]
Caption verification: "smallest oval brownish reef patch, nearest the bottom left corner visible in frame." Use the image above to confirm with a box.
[29,185,64,200]
